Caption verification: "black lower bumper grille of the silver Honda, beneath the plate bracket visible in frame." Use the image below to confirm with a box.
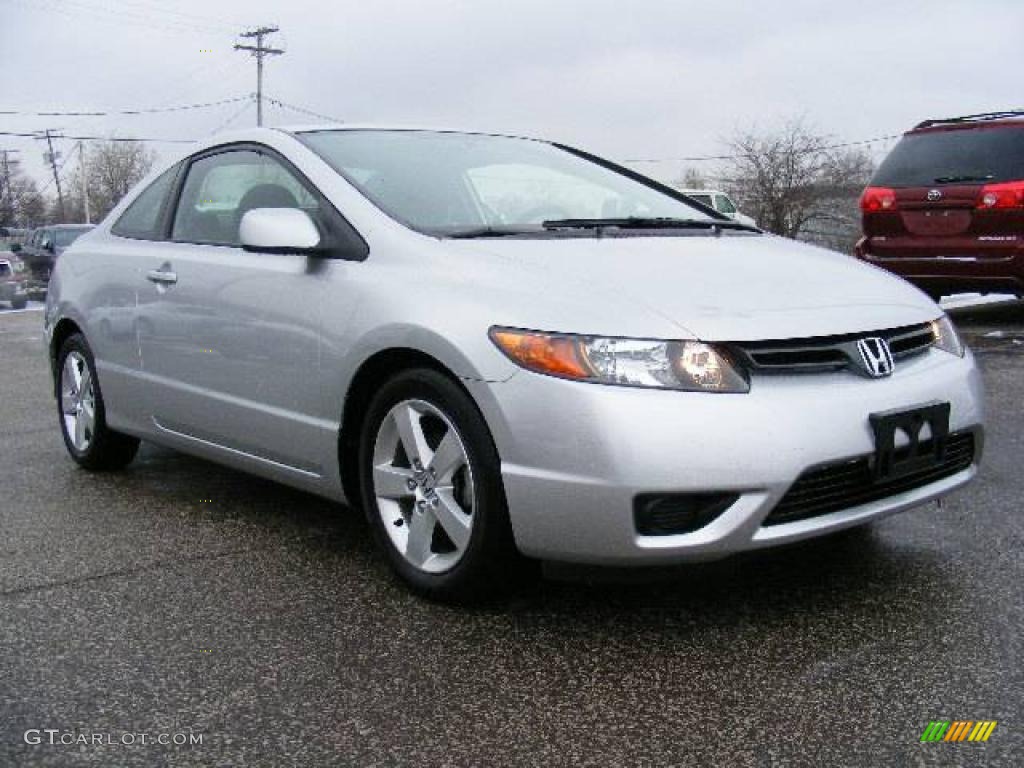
[764,432,975,525]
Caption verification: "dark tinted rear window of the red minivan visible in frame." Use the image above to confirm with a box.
[871,124,1024,186]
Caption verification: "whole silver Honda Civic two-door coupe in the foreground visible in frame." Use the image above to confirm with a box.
[45,126,983,600]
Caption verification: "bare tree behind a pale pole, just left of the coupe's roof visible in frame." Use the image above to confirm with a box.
[66,141,157,221]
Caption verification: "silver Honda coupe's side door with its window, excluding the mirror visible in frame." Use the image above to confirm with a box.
[138,146,327,476]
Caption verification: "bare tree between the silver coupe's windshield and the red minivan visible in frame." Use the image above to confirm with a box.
[726,120,873,249]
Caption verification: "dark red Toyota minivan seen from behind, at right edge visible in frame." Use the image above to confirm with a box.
[856,112,1024,299]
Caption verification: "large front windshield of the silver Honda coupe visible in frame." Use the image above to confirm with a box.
[299,130,715,236]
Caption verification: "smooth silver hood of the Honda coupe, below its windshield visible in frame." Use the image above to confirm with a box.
[446,233,941,341]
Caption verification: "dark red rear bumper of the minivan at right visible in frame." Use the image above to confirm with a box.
[854,238,1024,296]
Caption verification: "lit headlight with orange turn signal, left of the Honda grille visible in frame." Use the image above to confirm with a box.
[489,328,751,392]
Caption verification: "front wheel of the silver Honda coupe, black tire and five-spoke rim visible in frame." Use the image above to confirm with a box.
[358,369,522,603]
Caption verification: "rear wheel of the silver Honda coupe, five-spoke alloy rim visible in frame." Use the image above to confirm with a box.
[56,334,138,471]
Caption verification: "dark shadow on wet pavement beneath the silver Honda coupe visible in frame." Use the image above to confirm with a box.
[99,445,958,642]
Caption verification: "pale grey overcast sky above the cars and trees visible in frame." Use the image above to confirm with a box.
[0,0,1024,198]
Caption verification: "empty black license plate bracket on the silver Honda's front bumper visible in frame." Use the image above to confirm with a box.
[868,400,949,482]
